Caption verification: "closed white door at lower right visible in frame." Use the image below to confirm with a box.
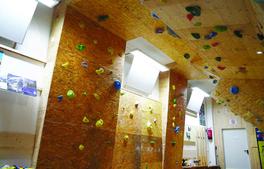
[223,129,250,169]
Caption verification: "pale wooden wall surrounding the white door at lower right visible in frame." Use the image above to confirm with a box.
[213,102,260,169]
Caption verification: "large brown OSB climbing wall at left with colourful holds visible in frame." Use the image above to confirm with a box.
[37,7,125,169]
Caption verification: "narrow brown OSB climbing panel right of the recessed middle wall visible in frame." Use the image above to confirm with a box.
[164,70,187,169]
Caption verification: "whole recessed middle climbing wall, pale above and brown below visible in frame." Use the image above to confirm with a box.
[113,90,162,169]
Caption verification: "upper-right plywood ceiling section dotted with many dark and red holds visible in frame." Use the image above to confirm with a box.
[144,0,264,79]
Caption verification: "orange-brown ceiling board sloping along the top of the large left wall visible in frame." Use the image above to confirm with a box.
[71,0,205,79]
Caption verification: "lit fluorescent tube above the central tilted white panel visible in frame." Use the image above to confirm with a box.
[130,50,169,72]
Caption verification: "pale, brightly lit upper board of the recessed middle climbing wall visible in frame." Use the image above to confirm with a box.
[117,90,162,137]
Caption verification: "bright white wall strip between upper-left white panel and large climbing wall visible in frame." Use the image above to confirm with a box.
[16,3,53,61]
